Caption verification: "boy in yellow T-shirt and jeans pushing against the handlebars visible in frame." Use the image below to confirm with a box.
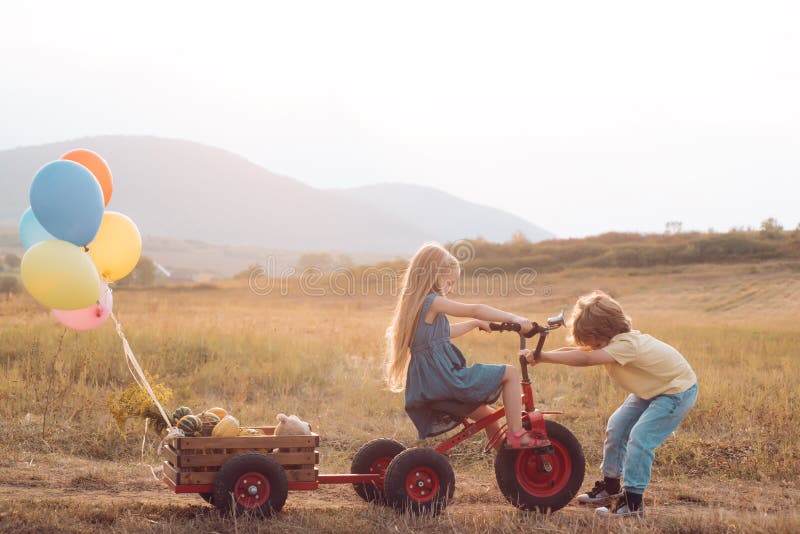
[520,291,697,517]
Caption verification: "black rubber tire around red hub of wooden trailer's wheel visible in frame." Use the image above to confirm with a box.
[212,452,289,517]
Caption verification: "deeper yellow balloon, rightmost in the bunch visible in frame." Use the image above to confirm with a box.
[88,211,142,282]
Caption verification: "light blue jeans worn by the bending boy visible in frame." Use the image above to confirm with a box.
[600,384,697,493]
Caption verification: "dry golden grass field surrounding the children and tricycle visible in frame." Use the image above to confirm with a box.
[0,262,800,532]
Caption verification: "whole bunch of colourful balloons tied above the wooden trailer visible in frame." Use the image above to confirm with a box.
[19,149,142,330]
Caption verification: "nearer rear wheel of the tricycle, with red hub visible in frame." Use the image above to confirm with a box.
[383,447,456,515]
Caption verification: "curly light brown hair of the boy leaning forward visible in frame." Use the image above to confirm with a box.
[569,290,631,349]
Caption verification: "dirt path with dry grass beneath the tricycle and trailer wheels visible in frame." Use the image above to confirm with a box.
[0,456,800,533]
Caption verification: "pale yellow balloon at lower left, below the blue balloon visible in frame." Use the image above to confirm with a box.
[20,239,100,310]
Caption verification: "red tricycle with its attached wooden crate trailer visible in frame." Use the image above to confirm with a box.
[163,313,585,516]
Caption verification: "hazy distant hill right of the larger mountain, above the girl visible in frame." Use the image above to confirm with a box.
[332,184,555,242]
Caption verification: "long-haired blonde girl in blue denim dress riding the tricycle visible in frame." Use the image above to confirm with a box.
[386,243,547,448]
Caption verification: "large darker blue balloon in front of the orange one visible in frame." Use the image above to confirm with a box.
[31,160,103,246]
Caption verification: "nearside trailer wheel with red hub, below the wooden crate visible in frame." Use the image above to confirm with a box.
[212,452,289,517]
